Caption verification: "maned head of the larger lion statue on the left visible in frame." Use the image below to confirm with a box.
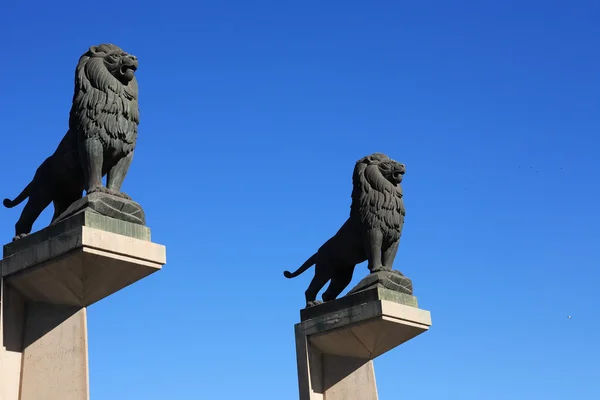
[69,44,139,153]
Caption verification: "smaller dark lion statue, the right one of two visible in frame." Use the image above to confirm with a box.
[283,153,406,307]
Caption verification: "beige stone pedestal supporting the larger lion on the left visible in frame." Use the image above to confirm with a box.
[0,211,166,400]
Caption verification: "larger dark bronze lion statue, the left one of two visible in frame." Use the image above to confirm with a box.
[3,44,139,240]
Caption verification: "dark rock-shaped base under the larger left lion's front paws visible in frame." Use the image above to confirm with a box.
[53,192,146,225]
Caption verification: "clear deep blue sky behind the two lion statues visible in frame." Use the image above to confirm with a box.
[0,0,600,400]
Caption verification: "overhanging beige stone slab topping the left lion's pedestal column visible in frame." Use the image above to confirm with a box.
[0,226,166,307]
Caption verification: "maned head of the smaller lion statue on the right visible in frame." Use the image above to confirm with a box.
[350,153,406,236]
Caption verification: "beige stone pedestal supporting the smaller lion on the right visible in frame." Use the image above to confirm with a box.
[295,287,431,400]
